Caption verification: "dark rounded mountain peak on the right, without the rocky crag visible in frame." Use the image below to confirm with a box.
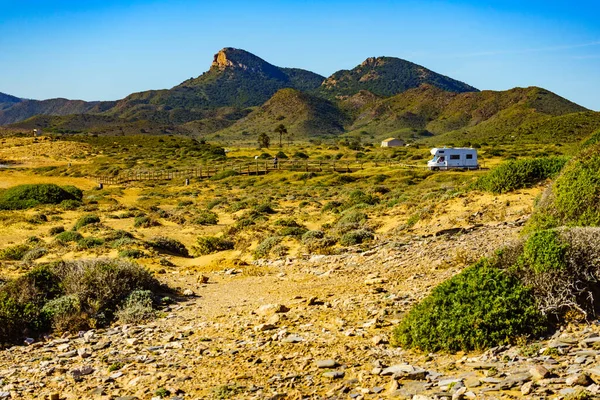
[318,57,478,98]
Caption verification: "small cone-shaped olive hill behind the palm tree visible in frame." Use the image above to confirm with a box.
[214,89,350,139]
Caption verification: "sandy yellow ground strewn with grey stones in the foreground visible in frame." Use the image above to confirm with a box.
[0,221,600,399]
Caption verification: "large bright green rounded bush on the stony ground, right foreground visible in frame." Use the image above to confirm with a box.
[393,259,548,352]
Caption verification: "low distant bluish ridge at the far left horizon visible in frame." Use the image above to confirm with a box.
[0,99,116,125]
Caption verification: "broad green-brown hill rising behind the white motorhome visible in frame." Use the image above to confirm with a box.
[342,85,594,145]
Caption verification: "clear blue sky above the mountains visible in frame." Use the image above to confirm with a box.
[0,0,600,110]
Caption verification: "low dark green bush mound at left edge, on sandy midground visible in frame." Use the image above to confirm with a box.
[0,184,83,210]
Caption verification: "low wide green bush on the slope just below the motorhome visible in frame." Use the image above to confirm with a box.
[474,157,567,194]
